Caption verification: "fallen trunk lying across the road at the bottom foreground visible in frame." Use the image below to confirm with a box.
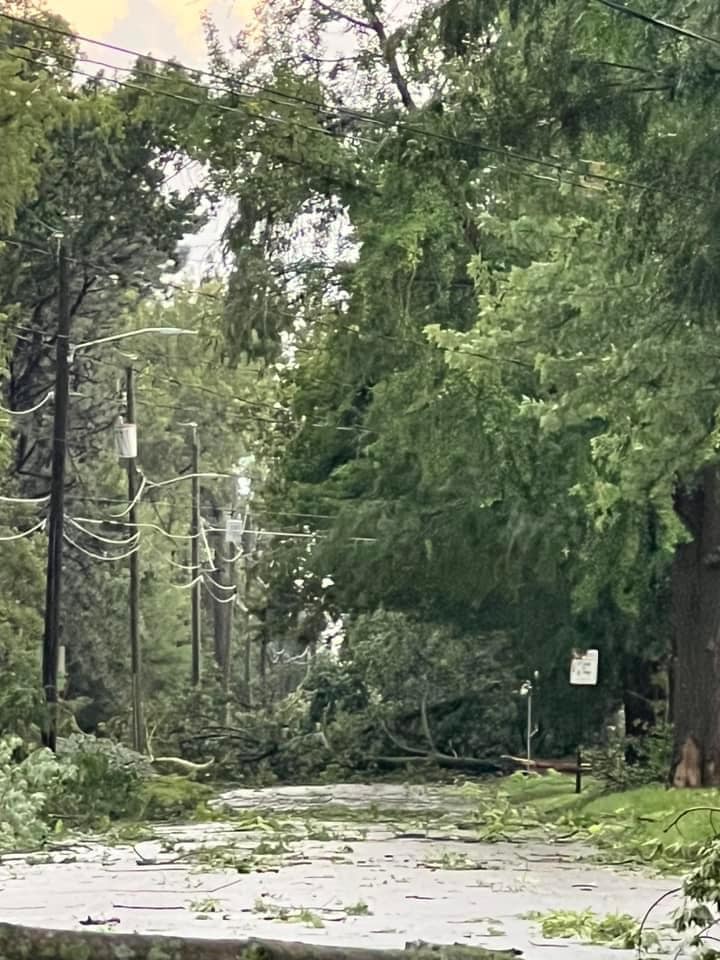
[0,923,520,960]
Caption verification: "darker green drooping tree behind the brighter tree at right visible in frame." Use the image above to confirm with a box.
[167,4,633,756]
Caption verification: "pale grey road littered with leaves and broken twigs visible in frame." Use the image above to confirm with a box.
[0,784,676,960]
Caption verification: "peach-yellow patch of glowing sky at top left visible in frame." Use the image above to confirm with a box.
[47,0,257,62]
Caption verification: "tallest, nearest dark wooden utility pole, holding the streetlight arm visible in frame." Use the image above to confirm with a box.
[42,240,71,752]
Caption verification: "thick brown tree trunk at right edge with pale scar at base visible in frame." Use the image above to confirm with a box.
[672,467,720,787]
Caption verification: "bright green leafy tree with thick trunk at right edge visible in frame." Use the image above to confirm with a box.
[420,3,720,785]
